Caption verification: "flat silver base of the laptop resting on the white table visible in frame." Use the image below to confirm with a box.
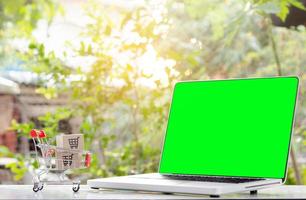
[87,173,282,197]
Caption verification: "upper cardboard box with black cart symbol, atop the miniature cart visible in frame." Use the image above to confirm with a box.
[56,134,84,151]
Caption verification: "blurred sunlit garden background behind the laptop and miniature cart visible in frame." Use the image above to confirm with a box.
[0,0,306,184]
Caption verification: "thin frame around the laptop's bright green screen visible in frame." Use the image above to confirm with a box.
[158,76,300,183]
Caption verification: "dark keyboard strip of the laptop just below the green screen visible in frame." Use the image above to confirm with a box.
[165,175,264,183]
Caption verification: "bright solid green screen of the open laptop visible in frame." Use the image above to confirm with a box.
[159,77,298,178]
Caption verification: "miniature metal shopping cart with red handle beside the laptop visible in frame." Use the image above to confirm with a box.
[30,129,91,192]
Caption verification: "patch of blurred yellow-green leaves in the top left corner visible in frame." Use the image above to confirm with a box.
[0,0,63,66]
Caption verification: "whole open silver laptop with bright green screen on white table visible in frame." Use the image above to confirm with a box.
[87,77,299,197]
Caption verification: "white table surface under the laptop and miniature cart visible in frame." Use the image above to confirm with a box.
[0,185,306,199]
